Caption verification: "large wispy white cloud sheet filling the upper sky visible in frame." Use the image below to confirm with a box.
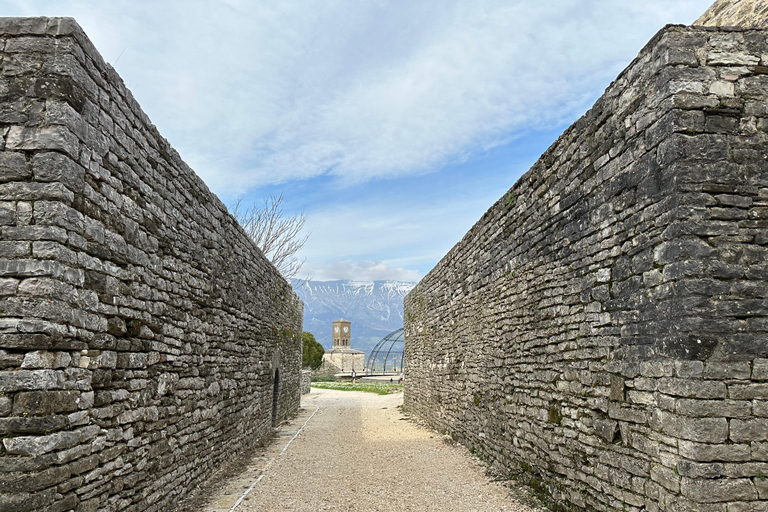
[8,0,710,196]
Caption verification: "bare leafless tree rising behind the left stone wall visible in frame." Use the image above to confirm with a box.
[232,194,309,279]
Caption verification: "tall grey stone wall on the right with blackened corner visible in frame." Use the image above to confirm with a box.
[405,26,768,512]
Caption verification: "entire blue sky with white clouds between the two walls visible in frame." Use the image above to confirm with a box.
[6,0,711,281]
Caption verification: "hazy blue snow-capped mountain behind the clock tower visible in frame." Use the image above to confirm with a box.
[291,279,416,354]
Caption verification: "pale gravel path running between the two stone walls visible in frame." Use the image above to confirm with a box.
[191,388,541,512]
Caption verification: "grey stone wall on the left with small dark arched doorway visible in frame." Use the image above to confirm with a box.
[0,18,302,512]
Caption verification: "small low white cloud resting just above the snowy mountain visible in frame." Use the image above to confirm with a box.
[301,260,421,282]
